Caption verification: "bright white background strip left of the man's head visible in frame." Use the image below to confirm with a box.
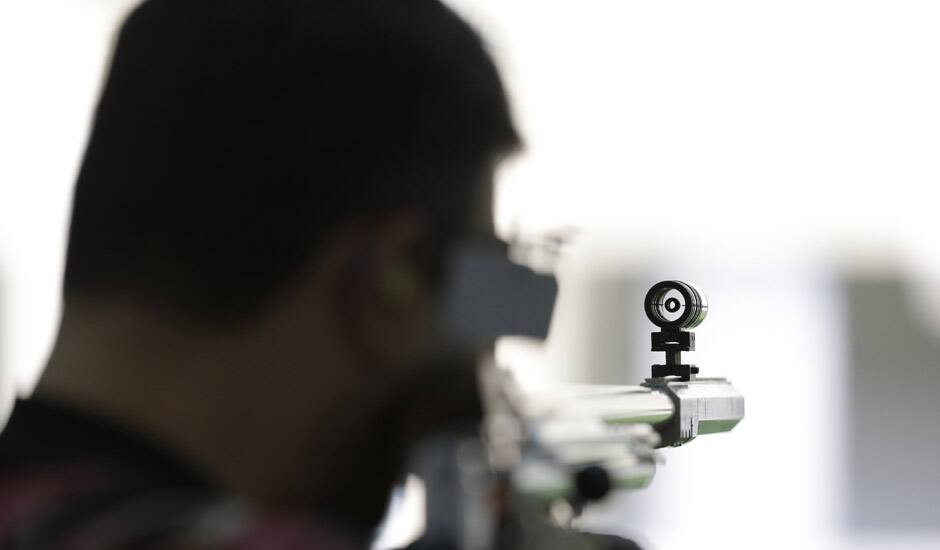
[0,0,140,406]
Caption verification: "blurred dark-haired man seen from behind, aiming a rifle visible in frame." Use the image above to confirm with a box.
[0,0,518,549]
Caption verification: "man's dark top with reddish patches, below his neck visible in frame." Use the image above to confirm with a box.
[0,399,368,550]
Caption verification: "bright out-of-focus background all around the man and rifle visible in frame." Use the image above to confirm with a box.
[0,0,940,549]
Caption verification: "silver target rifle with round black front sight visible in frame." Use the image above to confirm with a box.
[412,281,744,550]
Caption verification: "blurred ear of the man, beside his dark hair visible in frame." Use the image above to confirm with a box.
[349,212,434,368]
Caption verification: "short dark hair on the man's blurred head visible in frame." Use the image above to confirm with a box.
[65,0,518,320]
